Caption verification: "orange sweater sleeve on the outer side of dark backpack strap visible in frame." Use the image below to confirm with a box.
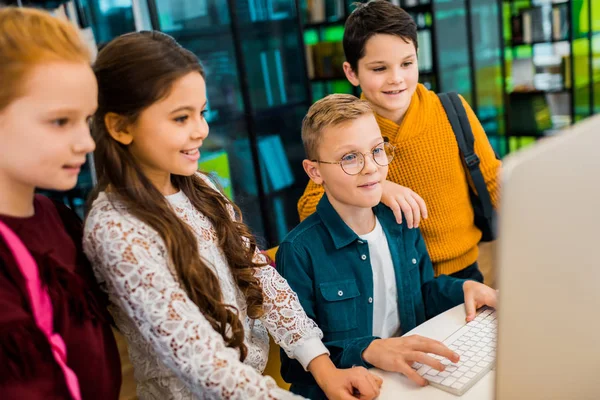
[460,96,502,209]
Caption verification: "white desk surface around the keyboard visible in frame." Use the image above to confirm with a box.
[370,304,494,400]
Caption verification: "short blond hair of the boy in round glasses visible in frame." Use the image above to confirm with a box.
[302,94,373,160]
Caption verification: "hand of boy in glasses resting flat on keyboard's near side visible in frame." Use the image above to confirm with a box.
[363,335,459,386]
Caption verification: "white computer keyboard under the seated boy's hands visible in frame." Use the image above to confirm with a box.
[412,308,498,396]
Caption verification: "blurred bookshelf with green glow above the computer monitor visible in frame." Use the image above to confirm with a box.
[501,0,600,151]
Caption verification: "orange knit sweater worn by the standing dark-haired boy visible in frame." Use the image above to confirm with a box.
[298,84,501,276]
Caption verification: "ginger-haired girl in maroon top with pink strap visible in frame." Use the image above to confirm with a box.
[0,7,121,400]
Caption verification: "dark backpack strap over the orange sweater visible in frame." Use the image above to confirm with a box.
[438,92,494,219]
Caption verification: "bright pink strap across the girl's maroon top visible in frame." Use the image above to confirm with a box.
[0,221,81,400]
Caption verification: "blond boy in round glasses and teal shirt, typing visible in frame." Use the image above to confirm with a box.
[277,94,496,400]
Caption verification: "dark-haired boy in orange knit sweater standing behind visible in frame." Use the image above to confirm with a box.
[298,0,501,282]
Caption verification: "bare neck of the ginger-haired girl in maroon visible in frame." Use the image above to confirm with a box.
[0,174,35,218]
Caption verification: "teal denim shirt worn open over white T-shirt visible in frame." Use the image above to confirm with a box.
[276,195,465,399]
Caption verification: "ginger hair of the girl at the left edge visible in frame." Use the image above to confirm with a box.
[0,7,91,111]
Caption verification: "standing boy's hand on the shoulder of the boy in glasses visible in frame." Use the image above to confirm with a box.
[381,181,427,228]
